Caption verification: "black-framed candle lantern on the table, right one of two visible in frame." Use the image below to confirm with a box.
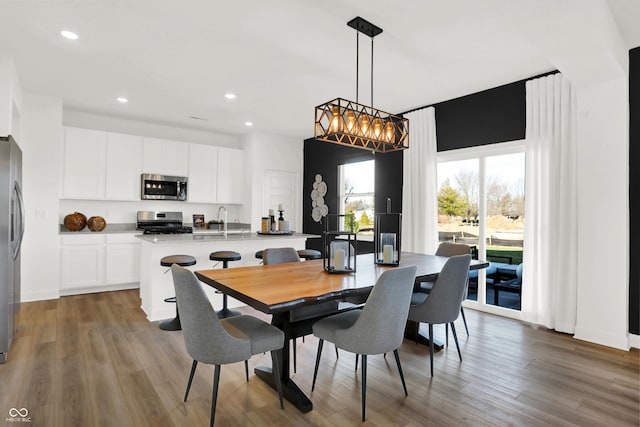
[374,213,402,267]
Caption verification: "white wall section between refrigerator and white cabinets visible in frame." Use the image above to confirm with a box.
[21,93,63,301]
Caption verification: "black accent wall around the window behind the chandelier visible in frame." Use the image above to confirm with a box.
[302,138,402,252]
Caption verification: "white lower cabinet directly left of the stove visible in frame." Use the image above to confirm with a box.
[106,234,140,285]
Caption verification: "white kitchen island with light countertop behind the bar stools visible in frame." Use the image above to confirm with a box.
[137,232,318,322]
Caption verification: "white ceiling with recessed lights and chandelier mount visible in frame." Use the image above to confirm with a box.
[0,0,640,138]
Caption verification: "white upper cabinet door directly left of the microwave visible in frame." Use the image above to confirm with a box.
[105,133,142,201]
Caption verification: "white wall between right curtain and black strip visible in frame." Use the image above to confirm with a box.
[575,76,629,349]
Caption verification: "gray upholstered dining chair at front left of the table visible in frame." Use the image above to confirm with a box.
[171,264,284,426]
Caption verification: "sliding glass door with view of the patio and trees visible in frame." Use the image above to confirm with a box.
[438,141,525,312]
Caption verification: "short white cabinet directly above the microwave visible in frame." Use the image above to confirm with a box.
[142,138,190,176]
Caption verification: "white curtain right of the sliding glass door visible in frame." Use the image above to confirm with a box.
[522,73,578,333]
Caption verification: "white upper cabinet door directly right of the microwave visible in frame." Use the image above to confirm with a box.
[187,144,218,203]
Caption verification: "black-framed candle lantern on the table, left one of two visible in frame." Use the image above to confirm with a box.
[322,213,358,274]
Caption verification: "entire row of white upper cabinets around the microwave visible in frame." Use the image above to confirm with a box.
[60,127,245,204]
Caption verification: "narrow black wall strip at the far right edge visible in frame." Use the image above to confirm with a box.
[629,47,640,335]
